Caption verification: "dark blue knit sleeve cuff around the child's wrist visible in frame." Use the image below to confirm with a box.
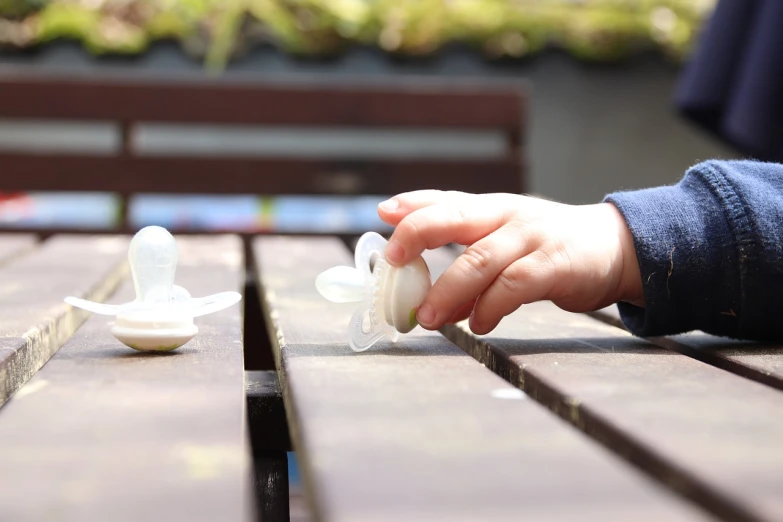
[605,164,741,336]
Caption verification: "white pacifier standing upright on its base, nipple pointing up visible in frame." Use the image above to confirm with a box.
[65,226,242,352]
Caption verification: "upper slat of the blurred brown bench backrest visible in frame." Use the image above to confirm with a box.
[0,70,524,131]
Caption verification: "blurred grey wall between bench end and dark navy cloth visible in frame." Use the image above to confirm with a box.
[525,51,736,203]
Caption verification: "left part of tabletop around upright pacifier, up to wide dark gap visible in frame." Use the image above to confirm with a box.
[0,236,252,521]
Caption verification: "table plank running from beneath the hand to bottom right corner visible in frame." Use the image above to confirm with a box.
[443,296,783,521]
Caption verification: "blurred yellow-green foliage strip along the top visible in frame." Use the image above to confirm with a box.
[0,0,716,69]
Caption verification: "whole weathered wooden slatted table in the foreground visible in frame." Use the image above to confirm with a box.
[0,236,783,522]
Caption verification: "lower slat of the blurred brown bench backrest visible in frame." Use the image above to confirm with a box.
[0,153,523,195]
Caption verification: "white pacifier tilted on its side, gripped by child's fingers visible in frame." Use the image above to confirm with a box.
[315,232,432,352]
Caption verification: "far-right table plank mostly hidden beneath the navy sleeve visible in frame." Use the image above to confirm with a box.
[590,306,783,390]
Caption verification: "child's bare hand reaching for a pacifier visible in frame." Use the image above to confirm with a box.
[378,190,643,334]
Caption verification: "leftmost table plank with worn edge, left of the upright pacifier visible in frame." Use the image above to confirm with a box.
[0,236,128,406]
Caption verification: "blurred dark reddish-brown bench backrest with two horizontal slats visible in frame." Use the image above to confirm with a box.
[0,68,529,233]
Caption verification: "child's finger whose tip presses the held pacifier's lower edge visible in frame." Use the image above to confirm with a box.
[416,222,535,329]
